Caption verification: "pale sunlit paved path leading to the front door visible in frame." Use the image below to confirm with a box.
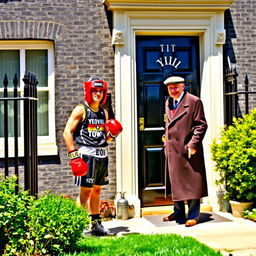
[104,212,256,256]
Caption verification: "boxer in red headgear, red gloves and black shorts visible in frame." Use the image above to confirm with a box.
[63,78,122,236]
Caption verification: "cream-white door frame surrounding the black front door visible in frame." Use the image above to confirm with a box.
[107,5,231,217]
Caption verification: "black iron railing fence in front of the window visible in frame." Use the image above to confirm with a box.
[0,72,38,195]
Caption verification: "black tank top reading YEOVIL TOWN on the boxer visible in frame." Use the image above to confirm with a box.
[74,103,108,147]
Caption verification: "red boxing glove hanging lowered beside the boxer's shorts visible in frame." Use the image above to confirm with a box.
[68,149,88,176]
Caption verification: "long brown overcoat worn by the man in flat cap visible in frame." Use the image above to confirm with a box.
[165,93,208,201]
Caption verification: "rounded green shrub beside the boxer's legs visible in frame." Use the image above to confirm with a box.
[28,194,89,255]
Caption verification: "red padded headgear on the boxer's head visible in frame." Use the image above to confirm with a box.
[84,77,108,105]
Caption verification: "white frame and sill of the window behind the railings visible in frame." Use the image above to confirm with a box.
[0,40,58,158]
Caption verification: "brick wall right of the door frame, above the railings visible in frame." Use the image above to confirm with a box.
[225,0,256,113]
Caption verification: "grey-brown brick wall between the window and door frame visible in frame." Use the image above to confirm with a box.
[0,0,116,199]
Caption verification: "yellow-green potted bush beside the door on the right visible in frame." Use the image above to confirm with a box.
[211,109,256,216]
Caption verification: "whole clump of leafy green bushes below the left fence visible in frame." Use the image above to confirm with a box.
[0,176,89,256]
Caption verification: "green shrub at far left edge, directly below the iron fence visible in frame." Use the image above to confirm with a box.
[0,176,34,255]
